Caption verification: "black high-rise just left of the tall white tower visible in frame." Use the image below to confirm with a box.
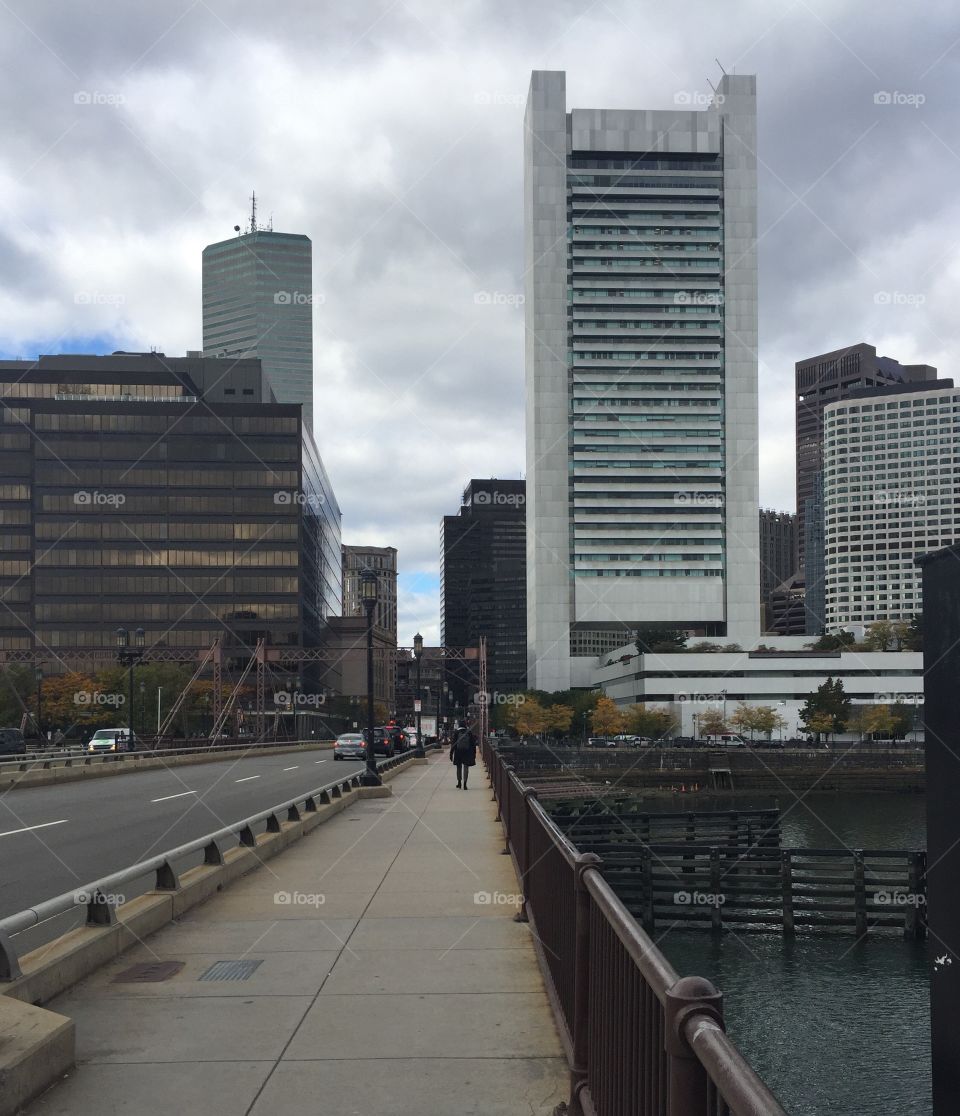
[440,480,527,704]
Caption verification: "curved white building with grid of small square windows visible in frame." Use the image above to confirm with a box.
[824,379,960,632]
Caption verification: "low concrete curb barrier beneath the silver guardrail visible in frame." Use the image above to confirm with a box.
[0,756,417,1116]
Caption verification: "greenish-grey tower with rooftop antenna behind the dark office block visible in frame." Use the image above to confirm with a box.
[203,215,314,430]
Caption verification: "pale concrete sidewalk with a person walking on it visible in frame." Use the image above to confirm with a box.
[29,754,568,1116]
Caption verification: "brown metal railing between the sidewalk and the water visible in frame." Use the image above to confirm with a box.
[481,740,786,1116]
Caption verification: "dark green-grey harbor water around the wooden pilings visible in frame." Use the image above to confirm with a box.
[655,795,928,1116]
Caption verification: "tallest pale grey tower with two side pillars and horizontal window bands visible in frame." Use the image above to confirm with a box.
[525,70,760,691]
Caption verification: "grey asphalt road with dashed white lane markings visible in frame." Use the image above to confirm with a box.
[0,748,364,918]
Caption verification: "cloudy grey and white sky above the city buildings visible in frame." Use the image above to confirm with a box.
[0,0,960,642]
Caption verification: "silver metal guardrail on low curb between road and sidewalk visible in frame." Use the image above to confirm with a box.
[0,745,415,981]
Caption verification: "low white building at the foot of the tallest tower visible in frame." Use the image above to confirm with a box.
[593,639,923,737]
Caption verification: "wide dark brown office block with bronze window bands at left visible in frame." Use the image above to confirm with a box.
[0,353,340,666]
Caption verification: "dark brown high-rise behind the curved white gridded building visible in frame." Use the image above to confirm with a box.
[796,341,937,566]
